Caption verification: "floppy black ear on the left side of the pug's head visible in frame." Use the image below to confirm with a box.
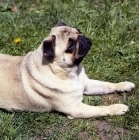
[43,35,56,62]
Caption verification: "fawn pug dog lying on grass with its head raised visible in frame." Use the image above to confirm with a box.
[0,23,135,119]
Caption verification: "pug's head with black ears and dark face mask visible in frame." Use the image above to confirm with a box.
[42,23,92,67]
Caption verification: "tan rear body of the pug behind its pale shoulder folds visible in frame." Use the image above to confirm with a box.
[0,54,29,110]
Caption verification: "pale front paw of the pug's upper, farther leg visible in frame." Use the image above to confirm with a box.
[116,82,135,92]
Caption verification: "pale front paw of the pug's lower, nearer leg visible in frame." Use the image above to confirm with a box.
[109,104,129,115]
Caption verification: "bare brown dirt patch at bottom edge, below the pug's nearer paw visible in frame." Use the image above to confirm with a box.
[93,121,126,140]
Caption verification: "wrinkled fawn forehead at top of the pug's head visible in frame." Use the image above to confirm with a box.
[51,26,81,37]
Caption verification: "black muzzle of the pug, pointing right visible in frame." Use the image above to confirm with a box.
[73,35,92,65]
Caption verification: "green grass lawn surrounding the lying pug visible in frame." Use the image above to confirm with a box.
[0,0,139,140]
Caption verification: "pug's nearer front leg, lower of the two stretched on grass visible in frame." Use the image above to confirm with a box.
[66,103,128,119]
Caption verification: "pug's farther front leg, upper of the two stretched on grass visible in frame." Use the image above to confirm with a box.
[84,79,135,95]
